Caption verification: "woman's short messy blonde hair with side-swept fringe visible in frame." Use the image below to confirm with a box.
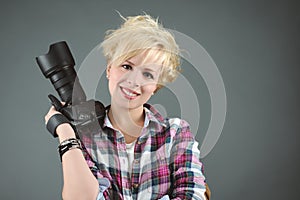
[101,14,180,89]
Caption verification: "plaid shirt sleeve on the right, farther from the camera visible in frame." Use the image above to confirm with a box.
[170,120,206,200]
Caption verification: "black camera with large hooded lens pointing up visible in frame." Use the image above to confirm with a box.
[36,41,105,131]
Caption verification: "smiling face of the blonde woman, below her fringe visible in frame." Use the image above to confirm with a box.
[107,53,161,109]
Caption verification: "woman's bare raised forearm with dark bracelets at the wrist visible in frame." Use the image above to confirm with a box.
[56,124,99,200]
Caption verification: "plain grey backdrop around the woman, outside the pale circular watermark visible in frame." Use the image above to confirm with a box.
[0,0,300,200]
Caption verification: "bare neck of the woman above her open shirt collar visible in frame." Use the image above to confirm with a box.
[108,104,144,143]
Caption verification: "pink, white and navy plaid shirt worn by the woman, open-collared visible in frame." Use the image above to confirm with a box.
[81,104,205,200]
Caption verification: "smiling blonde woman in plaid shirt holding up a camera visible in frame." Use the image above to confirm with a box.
[45,15,210,200]
